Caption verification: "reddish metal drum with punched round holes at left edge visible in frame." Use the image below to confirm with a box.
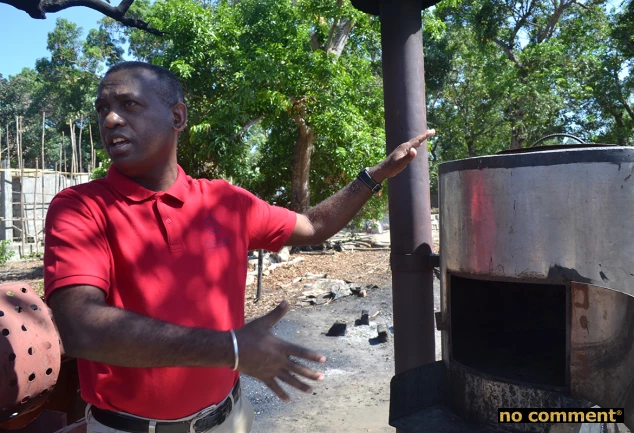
[0,283,61,424]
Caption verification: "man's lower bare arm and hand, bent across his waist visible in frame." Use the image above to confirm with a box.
[49,285,326,401]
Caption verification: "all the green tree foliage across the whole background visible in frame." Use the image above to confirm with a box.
[0,0,634,221]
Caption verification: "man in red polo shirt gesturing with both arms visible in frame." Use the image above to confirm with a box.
[44,62,434,433]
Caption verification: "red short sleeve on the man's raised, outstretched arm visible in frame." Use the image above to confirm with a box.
[238,188,297,251]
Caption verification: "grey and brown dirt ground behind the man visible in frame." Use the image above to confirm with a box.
[0,246,440,433]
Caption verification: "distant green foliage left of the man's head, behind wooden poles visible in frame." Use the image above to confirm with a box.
[0,19,112,171]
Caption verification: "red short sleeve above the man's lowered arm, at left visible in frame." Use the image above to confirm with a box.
[44,189,111,302]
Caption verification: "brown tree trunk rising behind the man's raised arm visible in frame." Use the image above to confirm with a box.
[291,116,315,213]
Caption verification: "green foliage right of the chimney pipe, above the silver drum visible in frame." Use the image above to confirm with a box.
[426,0,634,162]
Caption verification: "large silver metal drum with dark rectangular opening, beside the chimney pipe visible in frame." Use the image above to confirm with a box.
[439,144,634,431]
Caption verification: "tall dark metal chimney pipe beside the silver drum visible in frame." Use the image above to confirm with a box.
[380,0,435,374]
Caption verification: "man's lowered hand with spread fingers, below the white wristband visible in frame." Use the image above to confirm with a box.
[235,301,326,402]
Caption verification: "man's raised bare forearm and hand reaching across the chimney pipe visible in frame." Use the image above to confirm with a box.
[286,129,436,245]
